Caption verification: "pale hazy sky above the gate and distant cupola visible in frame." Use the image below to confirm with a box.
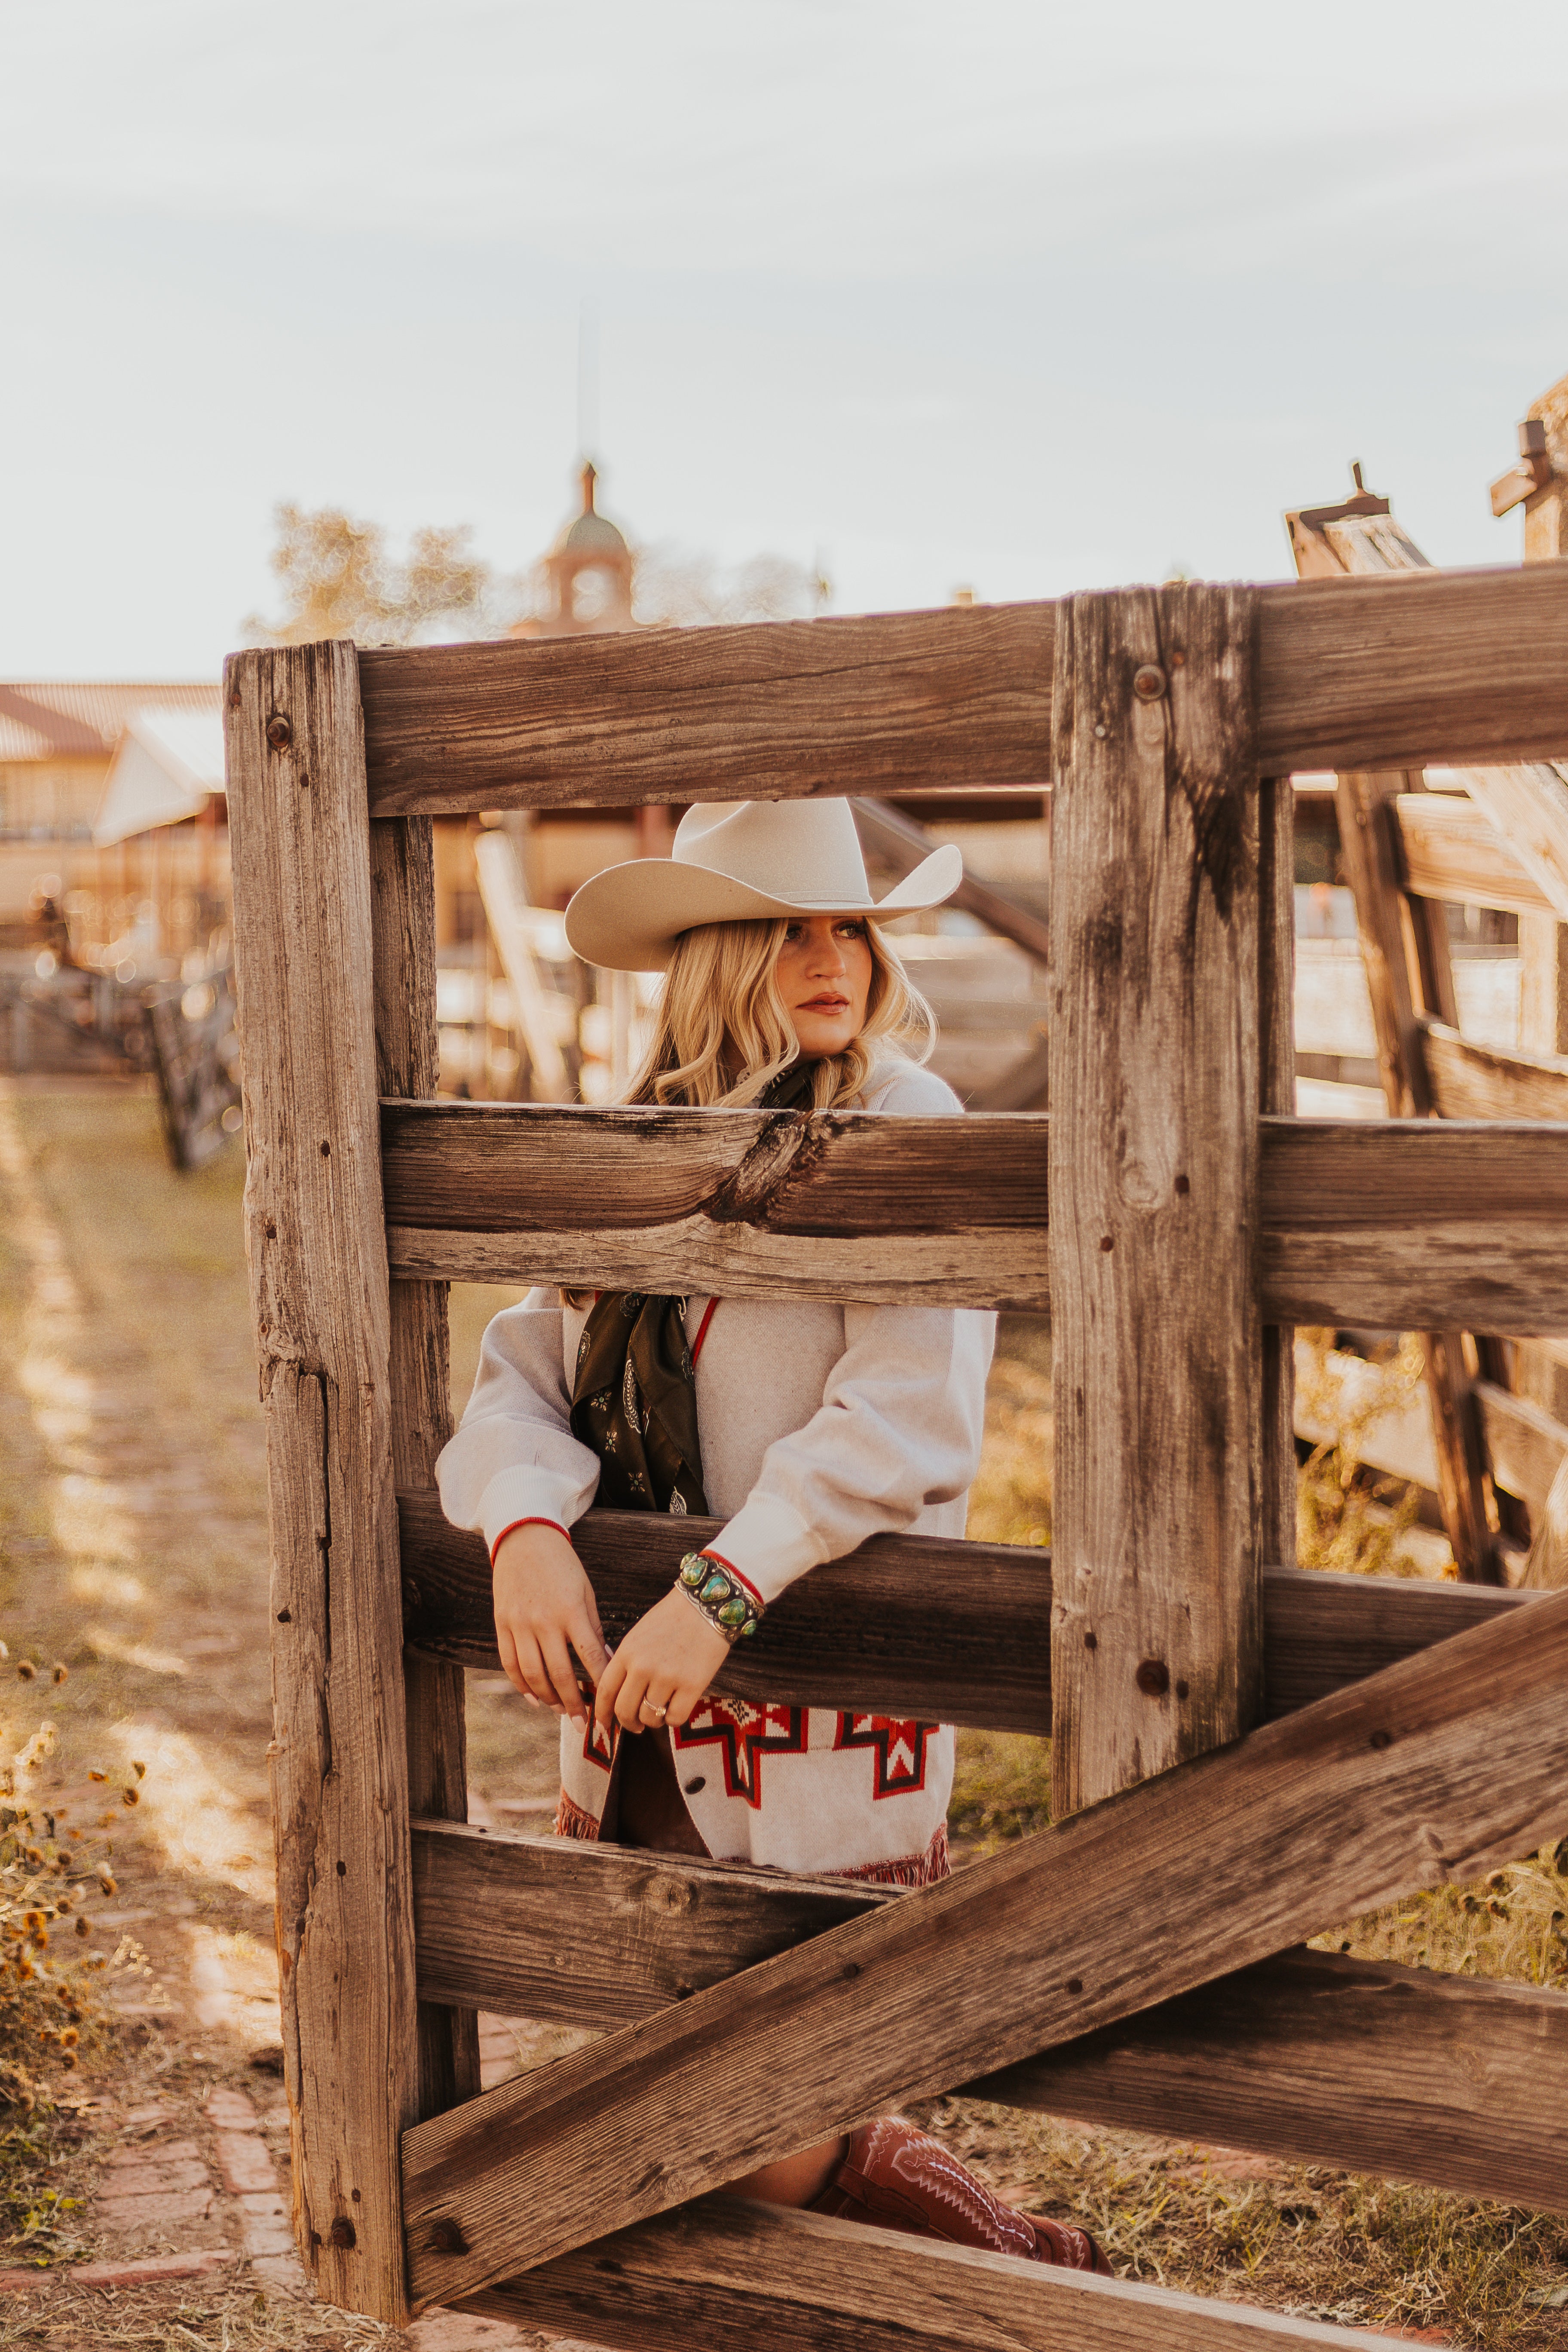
[0,0,1568,677]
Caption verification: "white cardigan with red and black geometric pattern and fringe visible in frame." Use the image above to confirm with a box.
[435,1061,997,1882]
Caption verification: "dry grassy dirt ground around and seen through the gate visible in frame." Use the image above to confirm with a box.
[0,1080,1568,2352]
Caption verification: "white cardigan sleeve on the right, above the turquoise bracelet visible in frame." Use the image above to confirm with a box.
[712,1068,997,1602]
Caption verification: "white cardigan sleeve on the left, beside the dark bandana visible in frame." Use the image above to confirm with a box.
[435,1291,600,1553]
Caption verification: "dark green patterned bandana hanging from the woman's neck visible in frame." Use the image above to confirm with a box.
[571,1061,816,1517]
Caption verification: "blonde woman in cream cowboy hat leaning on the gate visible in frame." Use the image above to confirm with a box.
[437,799,1105,2269]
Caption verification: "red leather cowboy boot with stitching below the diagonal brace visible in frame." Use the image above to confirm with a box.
[811,2114,1112,2277]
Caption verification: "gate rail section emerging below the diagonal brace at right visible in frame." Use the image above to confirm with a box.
[964,1950,1568,2213]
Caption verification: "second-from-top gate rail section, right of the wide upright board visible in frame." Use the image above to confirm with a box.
[1258,1120,1568,1331]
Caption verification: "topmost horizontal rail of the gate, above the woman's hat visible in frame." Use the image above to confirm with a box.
[360,564,1568,816]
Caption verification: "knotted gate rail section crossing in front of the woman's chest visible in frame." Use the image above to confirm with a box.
[383,1103,1046,1308]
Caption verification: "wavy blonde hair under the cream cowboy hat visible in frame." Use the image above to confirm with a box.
[621,915,936,1110]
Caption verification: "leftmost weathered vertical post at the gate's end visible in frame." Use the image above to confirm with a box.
[224,642,414,2321]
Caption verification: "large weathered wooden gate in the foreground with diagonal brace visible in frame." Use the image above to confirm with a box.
[226,564,1568,2352]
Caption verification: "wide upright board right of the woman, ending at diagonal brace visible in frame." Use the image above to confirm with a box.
[1051,586,1262,1818]
